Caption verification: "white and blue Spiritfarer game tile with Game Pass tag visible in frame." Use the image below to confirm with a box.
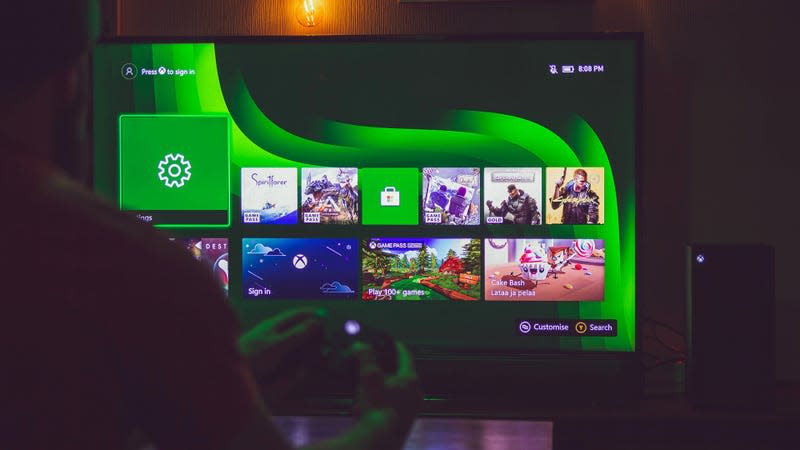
[242,167,297,225]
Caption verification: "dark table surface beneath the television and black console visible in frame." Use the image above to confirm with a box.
[276,389,800,450]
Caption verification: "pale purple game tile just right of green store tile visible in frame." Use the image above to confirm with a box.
[422,167,481,225]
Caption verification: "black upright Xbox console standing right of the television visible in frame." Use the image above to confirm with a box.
[686,244,775,409]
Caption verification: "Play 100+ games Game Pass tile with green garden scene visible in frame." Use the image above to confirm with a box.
[361,238,481,301]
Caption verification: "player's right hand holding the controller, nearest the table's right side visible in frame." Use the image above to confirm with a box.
[352,342,422,439]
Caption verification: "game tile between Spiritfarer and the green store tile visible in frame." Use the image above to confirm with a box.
[301,167,359,224]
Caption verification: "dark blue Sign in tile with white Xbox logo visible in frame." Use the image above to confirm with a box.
[242,238,359,299]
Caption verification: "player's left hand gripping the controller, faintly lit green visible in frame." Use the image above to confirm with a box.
[239,309,322,403]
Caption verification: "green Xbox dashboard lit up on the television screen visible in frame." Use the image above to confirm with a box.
[94,39,637,351]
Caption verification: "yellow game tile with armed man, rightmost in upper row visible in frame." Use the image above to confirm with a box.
[547,167,604,225]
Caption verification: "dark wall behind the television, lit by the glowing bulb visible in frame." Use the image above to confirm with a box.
[115,0,800,379]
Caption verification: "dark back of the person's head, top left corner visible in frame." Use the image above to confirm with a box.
[0,0,100,183]
